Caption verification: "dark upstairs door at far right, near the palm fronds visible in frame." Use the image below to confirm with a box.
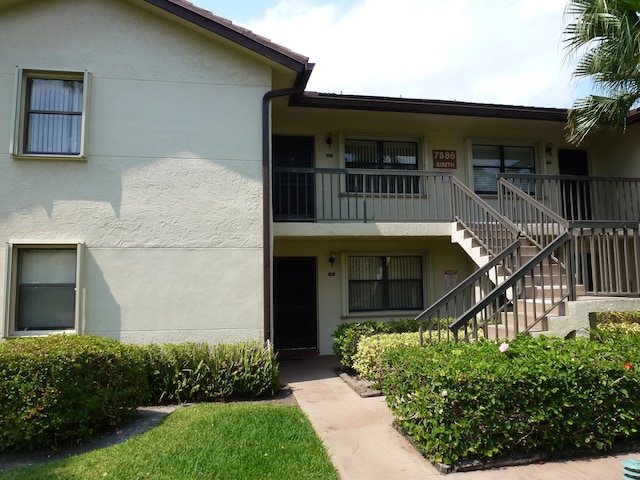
[558,148,591,220]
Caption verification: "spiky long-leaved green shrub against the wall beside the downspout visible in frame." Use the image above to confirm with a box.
[140,342,279,403]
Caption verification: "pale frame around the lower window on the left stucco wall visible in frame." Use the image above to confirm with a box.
[4,240,84,338]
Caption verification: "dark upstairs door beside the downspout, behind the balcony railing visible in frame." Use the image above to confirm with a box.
[273,135,315,222]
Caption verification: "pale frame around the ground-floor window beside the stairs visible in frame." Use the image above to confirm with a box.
[340,251,430,318]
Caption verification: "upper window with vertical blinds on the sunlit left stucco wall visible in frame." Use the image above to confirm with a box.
[13,69,88,158]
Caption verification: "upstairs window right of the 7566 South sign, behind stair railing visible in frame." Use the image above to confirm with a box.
[473,145,535,195]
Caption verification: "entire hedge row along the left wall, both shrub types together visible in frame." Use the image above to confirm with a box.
[0,335,279,450]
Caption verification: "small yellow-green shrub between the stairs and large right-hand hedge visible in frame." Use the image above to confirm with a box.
[353,332,420,383]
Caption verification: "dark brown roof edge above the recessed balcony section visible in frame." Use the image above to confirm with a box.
[292,92,568,122]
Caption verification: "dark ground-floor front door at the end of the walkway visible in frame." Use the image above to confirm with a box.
[273,257,318,353]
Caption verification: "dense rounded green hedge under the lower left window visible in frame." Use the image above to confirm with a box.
[0,335,149,449]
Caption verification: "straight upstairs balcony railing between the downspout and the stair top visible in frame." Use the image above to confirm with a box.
[273,167,453,222]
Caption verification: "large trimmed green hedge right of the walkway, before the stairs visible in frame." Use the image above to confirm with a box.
[383,331,640,464]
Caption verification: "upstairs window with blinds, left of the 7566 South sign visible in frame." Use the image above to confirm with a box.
[344,139,420,194]
